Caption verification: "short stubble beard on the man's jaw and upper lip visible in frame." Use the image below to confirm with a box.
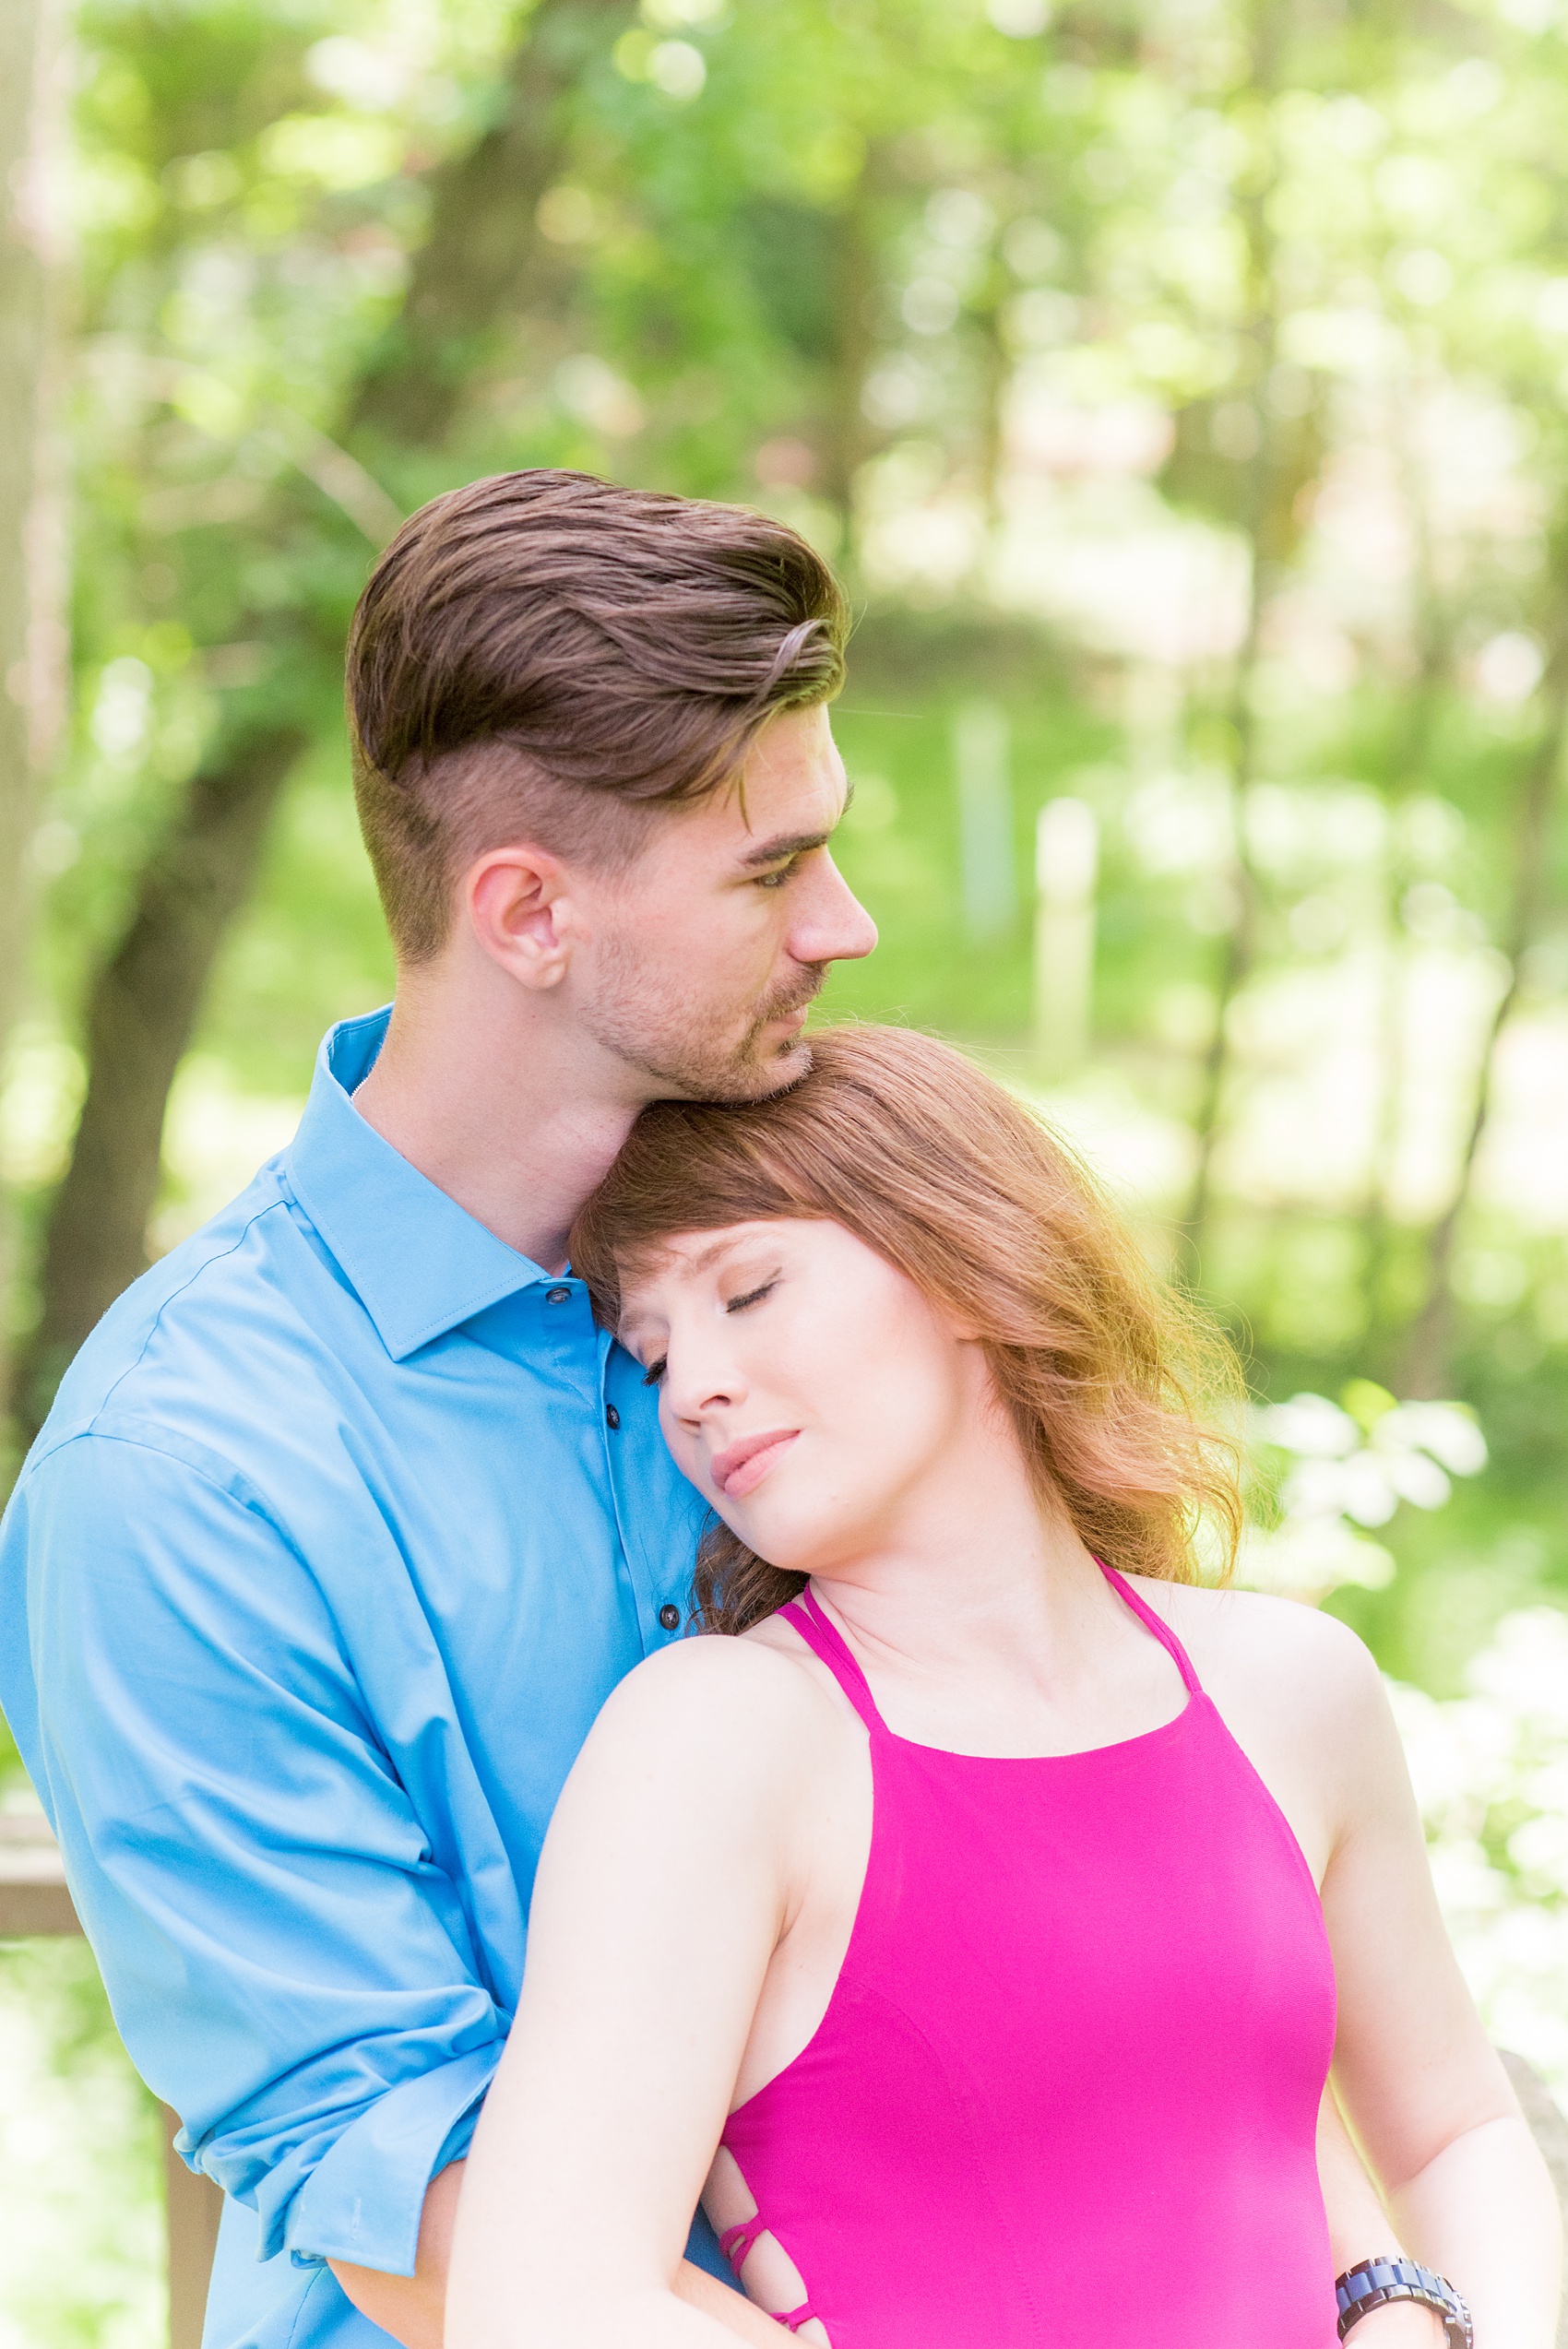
[583,946,826,1102]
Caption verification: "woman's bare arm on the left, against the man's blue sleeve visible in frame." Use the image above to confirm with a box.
[446,1640,837,2349]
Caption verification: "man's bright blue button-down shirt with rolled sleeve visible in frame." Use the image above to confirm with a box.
[0,1013,719,2349]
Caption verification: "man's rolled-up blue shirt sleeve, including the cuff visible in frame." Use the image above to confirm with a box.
[0,1433,510,2276]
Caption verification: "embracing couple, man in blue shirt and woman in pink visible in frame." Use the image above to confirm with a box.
[0,472,1556,2349]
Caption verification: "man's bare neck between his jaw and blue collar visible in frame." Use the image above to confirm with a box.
[355,991,639,1273]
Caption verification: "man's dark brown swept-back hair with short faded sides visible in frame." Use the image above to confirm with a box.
[348,472,849,963]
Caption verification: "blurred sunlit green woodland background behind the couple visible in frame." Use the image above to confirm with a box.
[0,0,1568,2349]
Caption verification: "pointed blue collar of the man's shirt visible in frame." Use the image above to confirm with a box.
[284,1005,550,1362]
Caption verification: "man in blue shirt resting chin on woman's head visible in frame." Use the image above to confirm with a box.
[0,472,874,2349]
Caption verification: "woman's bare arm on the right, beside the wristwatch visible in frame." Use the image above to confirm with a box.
[1321,1635,1561,2349]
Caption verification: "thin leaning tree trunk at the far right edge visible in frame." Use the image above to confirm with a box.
[1398,624,1568,1397]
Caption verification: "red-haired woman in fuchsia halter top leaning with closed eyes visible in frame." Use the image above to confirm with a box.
[446,1029,1559,2349]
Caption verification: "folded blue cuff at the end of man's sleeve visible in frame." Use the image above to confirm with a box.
[281,2039,503,2276]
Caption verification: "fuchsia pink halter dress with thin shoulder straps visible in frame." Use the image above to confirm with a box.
[724,1569,1337,2349]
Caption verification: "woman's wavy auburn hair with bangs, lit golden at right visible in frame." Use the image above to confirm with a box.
[571,1026,1241,1632]
